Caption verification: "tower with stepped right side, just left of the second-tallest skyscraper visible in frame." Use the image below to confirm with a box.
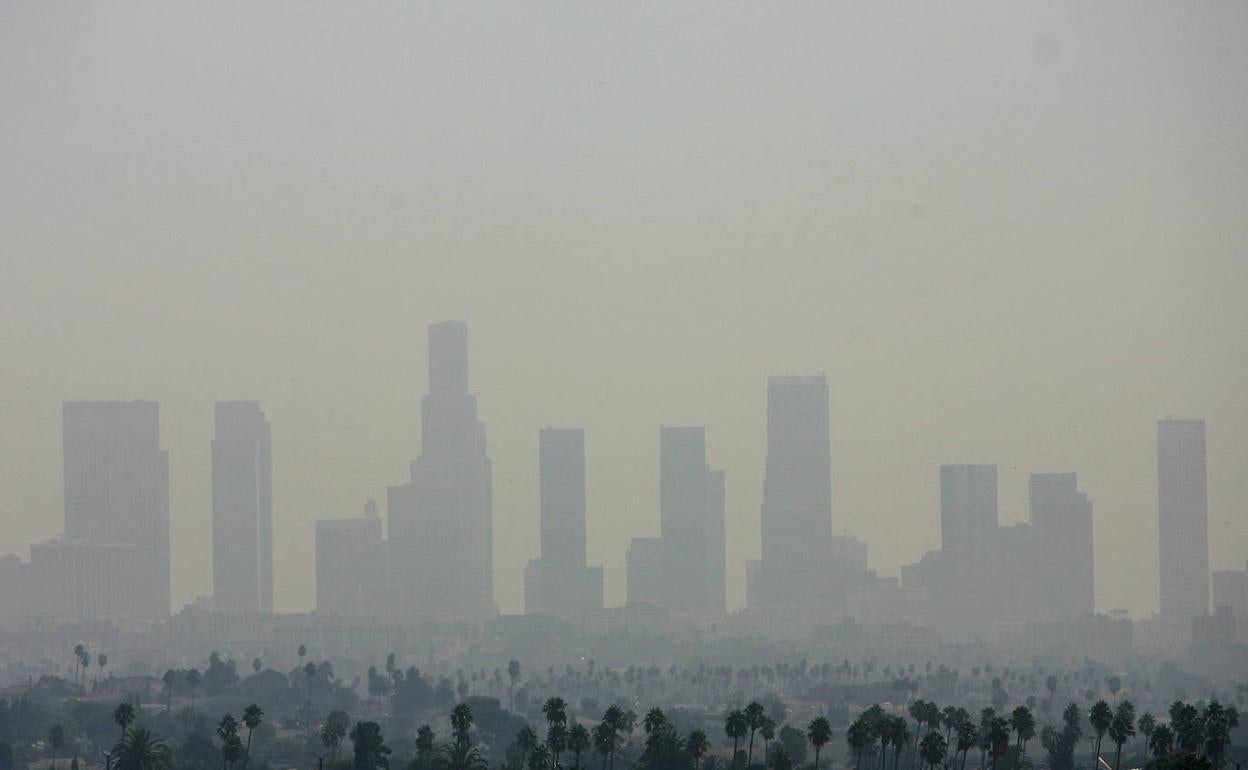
[659,428,725,613]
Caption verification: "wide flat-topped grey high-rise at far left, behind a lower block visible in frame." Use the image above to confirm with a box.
[62,401,170,618]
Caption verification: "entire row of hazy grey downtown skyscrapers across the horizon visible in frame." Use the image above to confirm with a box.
[0,322,1228,634]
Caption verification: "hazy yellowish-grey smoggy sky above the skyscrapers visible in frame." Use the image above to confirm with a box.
[0,0,1248,613]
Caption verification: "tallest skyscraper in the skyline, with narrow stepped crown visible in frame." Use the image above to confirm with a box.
[387,322,494,620]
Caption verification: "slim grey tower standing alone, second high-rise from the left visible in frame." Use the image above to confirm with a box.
[212,401,273,615]
